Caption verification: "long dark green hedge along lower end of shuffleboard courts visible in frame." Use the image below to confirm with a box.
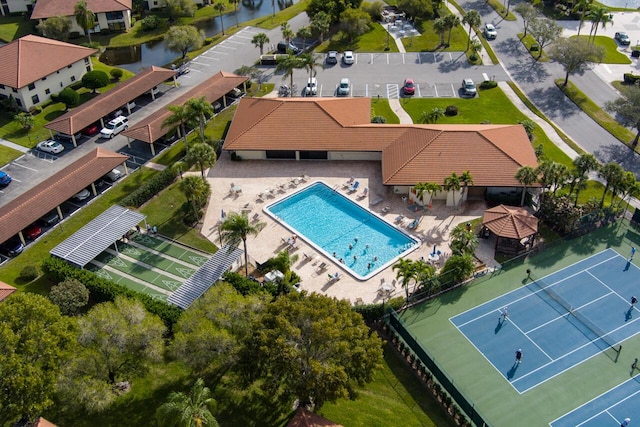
[42,257,182,331]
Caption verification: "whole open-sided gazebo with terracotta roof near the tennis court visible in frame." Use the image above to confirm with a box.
[482,205,538,255]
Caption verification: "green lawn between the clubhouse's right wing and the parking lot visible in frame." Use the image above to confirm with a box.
[400,88,572,166]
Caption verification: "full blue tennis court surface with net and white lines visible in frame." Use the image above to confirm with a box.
[450,249,640,394]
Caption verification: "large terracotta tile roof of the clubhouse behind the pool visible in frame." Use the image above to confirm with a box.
[224,98,538,186]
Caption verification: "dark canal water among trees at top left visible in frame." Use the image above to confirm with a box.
[100,0,298,73]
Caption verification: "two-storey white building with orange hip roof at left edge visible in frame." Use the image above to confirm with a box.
[0,35,97,111]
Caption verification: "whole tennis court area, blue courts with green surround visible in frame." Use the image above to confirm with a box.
[399,221,640,427]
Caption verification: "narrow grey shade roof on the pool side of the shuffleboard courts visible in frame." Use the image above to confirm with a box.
[167,245,242,310]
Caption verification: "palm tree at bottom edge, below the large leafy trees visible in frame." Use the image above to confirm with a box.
[156,378,218,427]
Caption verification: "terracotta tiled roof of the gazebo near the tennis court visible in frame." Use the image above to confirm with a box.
[482,205,538,240]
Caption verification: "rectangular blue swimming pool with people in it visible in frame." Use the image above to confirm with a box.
[264,182,419,280]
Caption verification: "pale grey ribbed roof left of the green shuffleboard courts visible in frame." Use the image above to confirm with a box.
[50,205,147,268]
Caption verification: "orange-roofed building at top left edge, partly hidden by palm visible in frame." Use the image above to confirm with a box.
[32,0,132,34]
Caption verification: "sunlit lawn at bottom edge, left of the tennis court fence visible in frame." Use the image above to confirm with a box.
[320,345,455,427]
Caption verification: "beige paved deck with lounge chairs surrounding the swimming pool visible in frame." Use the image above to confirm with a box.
[202,152,495,304]
